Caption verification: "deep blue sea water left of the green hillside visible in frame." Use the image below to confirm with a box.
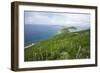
[24,24,60,46]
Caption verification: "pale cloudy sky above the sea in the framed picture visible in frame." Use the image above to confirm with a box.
[24,11,90,27]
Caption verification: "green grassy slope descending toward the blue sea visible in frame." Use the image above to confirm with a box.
[24,30,90,61]
